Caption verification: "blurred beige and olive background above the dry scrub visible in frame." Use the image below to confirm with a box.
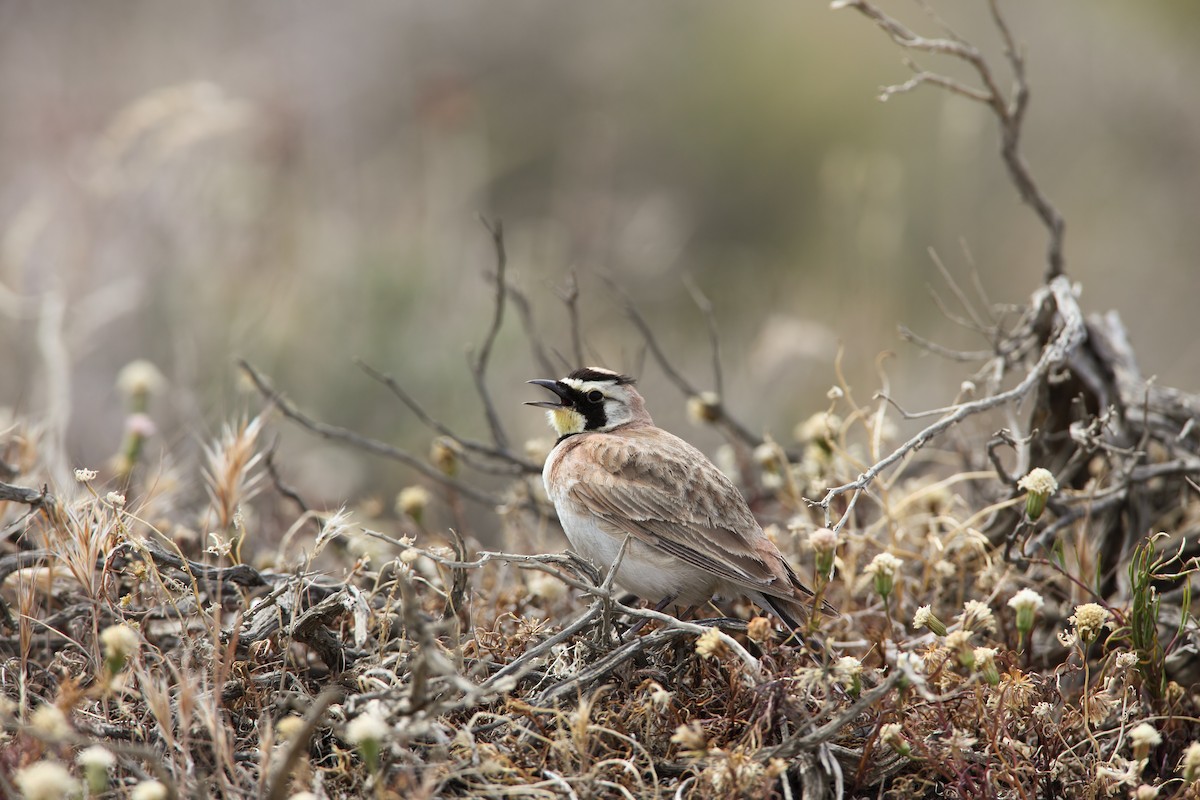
[0,0,1200,504]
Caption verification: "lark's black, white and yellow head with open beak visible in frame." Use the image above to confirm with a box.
[526,367,650,437]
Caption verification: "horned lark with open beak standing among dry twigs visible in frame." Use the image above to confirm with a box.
[528,367,830,630]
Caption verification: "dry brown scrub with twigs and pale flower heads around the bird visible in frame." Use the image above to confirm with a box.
[0,0,1200,799]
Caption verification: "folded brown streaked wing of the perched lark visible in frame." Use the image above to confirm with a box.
[568,431,811,597]
